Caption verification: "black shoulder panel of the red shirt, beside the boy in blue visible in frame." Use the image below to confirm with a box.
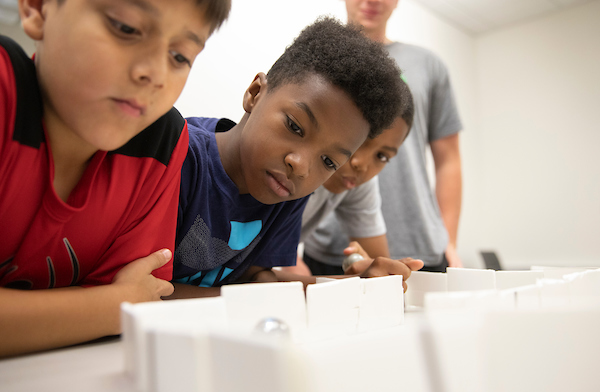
[112,108,187,166]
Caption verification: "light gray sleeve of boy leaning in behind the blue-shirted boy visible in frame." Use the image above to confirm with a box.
[335,176,386,238]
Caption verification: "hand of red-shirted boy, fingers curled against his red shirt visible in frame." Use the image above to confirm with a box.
[112,249,174,303]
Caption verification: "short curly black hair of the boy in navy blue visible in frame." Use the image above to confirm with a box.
[267,17,403,138]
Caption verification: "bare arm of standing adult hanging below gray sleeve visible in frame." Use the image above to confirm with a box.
[431,133,462,267]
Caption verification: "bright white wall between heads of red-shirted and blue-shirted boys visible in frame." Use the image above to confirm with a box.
[175,0,345,121]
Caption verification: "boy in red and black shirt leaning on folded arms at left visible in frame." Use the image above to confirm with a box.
[0,0,230,355]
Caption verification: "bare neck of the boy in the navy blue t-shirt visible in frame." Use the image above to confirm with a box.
[215,115,248,194]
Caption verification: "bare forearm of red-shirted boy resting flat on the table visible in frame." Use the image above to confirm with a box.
[0,286,126,356]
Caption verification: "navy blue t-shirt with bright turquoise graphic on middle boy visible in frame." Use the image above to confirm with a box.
[173,118,308,287]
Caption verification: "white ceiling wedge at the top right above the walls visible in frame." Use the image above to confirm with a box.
[414,0,592,35]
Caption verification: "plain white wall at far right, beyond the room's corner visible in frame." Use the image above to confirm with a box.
[476,1,600,267]
